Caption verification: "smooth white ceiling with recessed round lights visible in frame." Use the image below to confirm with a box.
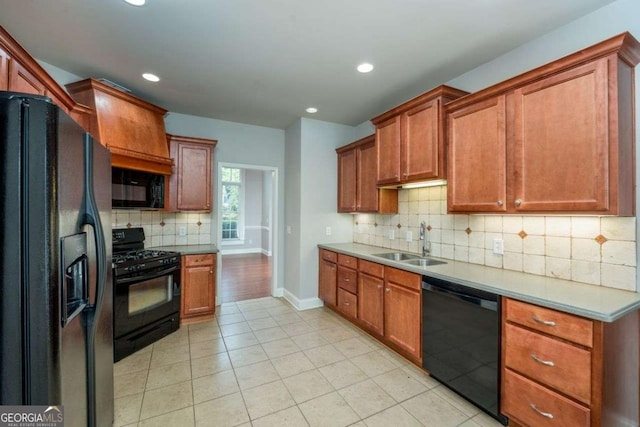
[0,0,613,129]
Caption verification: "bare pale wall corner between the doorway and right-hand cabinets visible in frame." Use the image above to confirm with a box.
[285,118,358,308]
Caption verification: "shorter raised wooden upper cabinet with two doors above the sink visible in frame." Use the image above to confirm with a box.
[371,86,467,185]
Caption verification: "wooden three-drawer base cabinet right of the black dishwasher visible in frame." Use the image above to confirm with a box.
[501,298,640,427]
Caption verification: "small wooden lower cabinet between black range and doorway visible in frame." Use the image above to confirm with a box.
[180,254,216,323]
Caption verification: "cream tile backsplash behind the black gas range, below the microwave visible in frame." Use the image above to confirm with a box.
[111,210,211,248]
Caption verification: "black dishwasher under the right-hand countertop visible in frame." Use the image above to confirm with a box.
[422,276,508,425]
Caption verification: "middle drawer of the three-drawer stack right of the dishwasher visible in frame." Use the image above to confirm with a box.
[504,324,591,405]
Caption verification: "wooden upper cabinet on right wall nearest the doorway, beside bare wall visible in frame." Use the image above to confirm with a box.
[336,135,398,213]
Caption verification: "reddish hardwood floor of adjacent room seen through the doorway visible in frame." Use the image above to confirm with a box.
[220,254,272,303]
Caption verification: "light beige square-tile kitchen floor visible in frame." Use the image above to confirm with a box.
[114,298,500,427]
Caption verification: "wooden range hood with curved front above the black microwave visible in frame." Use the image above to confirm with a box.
[66,79,173,175]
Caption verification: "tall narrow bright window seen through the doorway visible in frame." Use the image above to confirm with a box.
[222,167,242,240]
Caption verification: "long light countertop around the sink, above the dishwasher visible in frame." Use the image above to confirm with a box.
[318,243,640,322]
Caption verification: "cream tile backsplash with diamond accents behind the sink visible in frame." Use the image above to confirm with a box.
[353,186,637,291]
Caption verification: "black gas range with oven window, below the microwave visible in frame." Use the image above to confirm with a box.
[112,227,180,361]
